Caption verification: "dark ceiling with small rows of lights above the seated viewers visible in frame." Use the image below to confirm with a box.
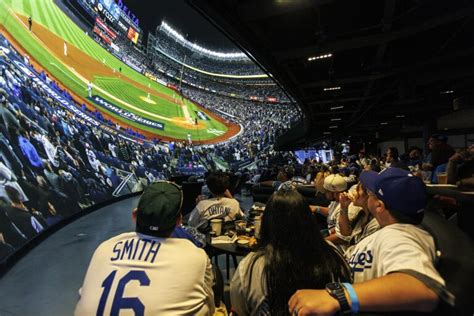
[188,0,474,145]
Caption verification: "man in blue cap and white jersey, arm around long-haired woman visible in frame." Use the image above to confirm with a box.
[288,168,446,315]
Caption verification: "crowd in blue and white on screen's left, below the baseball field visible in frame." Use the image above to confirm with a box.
[0,38,213,258]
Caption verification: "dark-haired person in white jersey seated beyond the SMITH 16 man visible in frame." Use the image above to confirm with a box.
[188,171,243,232]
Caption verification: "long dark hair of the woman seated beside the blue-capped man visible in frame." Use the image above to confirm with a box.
[250,190,351,315]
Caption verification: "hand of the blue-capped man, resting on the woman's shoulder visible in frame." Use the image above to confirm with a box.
[288,290,340,316]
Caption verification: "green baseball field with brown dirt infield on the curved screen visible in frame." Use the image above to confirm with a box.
[0,0,239,143]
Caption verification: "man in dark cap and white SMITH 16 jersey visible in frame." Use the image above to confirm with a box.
[75,181,214,315]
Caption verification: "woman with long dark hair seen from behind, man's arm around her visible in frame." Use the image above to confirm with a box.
[230,190,350,316]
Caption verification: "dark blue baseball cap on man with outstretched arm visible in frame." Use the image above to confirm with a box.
[359,168,426,216]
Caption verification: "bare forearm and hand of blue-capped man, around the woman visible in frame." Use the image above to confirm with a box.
[288,272,438,315]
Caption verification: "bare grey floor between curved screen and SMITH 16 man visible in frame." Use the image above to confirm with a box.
[0,197,139,316]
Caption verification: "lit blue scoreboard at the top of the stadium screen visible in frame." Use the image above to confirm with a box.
[77,0,142,45]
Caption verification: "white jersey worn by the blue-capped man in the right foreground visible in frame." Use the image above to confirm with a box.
[346,224,444,285]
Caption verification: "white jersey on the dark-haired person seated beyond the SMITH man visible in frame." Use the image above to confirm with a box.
[188,197,243,229]
